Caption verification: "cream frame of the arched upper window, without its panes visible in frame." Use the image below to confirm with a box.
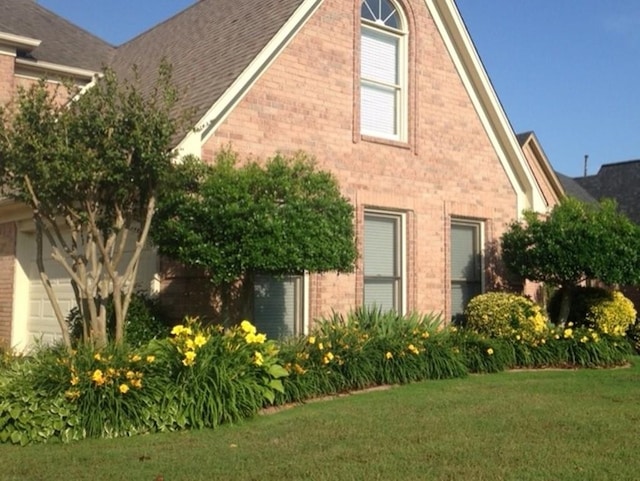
[360,0,409,142]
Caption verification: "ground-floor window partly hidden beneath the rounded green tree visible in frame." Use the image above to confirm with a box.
[253,275,304,339]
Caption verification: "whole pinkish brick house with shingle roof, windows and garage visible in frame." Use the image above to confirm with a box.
[0,0,562,344]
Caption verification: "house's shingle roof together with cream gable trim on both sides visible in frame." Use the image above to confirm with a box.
[0,0,560,216]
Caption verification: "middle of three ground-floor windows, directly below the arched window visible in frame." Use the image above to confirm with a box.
[364,213,402,312]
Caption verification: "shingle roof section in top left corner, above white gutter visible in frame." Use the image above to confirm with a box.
[0,0,114,71]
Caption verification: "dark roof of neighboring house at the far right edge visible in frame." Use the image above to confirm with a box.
[574,160,640,223]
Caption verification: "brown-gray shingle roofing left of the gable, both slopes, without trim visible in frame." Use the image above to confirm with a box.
[0,0,303,141]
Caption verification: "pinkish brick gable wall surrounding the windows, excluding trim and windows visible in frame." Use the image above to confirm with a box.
[174,0,516,318]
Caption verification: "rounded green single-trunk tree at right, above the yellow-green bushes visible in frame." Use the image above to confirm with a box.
[501,198,640,323]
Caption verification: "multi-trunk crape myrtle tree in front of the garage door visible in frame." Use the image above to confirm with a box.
[0,65,186,345]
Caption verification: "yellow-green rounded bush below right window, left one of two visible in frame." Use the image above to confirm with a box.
[465,292,547,339]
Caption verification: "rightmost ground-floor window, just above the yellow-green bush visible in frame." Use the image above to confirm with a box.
[451,221,482,319]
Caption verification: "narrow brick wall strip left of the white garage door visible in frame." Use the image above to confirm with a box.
[0,222,16,345]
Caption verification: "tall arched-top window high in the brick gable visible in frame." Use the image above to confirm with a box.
[360,0,408,141]
